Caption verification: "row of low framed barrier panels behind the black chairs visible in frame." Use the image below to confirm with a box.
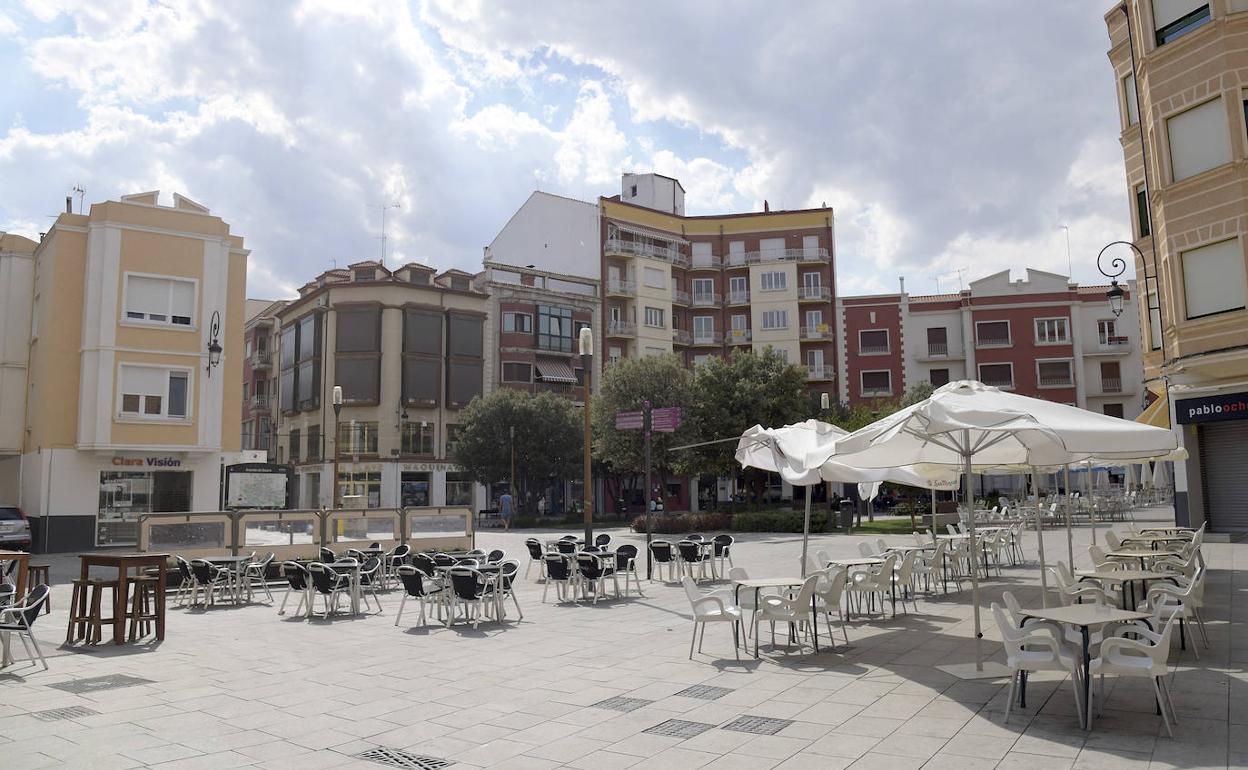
[139,508,477,559]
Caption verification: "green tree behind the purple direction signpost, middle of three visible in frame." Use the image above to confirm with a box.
[592,356,693,511]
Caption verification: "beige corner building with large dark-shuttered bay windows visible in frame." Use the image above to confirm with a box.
[273,261,488,508]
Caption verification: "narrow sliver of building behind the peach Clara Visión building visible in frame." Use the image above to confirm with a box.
[241,300,286,458]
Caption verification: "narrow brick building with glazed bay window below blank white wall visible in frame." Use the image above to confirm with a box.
[475,262,602,403]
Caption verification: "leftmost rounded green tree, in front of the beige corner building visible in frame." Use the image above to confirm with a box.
[452,388,584,510]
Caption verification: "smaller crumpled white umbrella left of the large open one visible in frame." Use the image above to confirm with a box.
[735,419,958,577]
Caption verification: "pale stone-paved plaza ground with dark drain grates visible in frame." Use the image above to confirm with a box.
[0,508,1248,770]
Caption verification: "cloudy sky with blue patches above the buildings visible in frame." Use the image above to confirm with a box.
[0,0,1129,297]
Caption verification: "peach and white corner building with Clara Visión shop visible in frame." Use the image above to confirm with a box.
[0,192,248,552]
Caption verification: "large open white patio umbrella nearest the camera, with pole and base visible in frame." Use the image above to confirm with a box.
[805,379,1176,678]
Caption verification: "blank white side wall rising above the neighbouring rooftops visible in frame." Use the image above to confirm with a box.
[485,191,602,278]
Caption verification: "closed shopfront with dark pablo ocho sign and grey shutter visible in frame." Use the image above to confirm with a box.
[1174,393,1248,532]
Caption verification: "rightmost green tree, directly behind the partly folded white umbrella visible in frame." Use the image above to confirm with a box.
[680,348,817,497]
